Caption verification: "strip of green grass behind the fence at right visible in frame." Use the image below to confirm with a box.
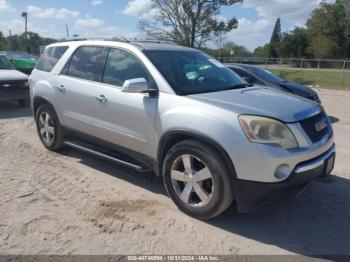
[269,67,350,90]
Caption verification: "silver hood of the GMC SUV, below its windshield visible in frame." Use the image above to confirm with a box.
[189,86,322,123]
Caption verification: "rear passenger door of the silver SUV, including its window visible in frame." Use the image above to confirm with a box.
[56,46,106,134]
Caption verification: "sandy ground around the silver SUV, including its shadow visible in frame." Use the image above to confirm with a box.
[0,90,350,256]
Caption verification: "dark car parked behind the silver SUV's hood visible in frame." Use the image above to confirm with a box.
[226,64,321,103]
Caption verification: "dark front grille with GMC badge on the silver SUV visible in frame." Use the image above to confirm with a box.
[300,112,331,143]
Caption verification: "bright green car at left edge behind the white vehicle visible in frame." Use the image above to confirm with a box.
[0,51,37,75]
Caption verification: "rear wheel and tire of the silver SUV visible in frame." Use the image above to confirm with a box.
[35,104,64,151]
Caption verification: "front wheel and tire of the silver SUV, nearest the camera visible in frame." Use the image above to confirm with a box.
[163,140,234,219]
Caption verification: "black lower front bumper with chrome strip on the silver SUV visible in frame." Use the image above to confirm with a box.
[235,144,335,213]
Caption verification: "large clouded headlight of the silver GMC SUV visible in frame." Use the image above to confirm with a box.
[239,115,298,149]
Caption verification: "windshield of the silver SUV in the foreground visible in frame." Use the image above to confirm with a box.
[144,50,246,95]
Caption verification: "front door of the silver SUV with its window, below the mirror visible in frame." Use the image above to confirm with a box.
[93,48,158,156]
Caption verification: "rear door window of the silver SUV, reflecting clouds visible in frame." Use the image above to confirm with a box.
[65,46,105,81]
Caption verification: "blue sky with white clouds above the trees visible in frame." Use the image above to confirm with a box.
[0,0,335,51]
